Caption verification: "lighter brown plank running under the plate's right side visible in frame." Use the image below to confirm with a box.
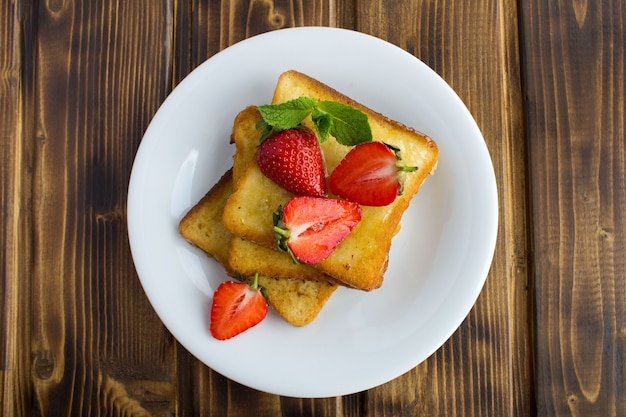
[356,0,532,416]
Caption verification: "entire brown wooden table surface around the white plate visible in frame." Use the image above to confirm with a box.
[0,0,626,417]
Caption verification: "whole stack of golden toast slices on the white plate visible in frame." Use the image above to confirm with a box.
[179,71,438,326]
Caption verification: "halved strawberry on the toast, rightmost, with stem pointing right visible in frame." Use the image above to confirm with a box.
[328,142,417,206]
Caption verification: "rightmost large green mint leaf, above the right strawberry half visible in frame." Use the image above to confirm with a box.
[316,100,372,146]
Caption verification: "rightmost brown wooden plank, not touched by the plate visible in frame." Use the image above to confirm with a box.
[521,1,626,416]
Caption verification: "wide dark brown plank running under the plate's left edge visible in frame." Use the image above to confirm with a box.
[25,1,177,416]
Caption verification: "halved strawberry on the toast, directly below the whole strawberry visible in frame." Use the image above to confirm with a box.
[274,196,361,264]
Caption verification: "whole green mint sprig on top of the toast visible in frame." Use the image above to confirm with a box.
[257,97,372,146]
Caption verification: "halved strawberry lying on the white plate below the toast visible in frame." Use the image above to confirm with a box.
[211,275,267,340]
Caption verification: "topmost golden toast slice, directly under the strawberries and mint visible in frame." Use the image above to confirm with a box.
[222,71,438,291]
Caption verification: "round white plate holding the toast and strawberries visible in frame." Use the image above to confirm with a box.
[128,27,498,397]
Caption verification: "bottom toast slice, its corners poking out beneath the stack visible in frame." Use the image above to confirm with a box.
[178,169,337,326]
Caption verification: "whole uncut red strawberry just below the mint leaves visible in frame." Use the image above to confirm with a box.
[256,127,326,197]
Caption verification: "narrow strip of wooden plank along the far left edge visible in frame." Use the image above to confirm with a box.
[0,2,32,416]
